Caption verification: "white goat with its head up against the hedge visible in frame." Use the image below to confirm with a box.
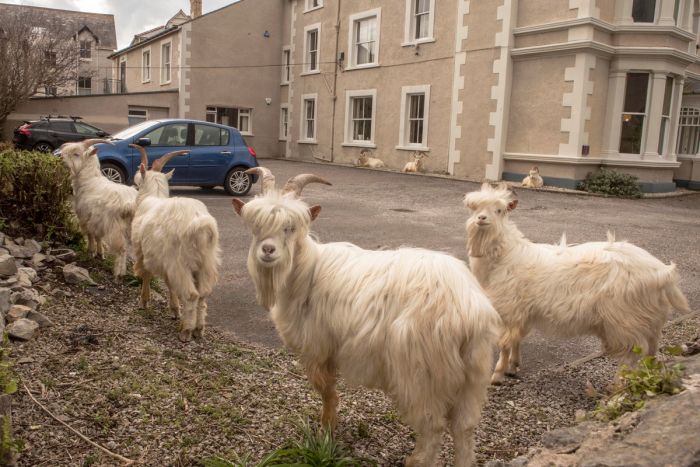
[61,139,136,278]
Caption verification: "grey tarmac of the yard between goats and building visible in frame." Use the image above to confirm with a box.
[171,159,700,371]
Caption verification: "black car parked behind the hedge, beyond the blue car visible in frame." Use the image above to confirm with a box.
[12,116,109,152]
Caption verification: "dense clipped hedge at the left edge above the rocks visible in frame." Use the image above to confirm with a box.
[0,149,80,243]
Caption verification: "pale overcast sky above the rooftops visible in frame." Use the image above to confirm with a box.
[0,0,237,49]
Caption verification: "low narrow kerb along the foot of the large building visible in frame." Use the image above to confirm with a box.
[258,157,700,200]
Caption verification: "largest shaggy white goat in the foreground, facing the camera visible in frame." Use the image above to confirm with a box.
[233,167,500,467]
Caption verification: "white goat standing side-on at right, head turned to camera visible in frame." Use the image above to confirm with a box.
[464,184,688,383]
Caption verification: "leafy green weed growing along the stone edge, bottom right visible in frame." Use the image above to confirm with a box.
[589,347,683,421]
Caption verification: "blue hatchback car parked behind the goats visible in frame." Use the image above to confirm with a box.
[56,119,258,196]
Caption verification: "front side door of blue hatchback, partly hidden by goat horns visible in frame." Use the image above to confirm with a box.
[131,122,190,184]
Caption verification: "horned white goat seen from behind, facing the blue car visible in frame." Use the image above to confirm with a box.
[130,144,221,342]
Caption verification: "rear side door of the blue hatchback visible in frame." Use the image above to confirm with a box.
[189,123,233,186]
